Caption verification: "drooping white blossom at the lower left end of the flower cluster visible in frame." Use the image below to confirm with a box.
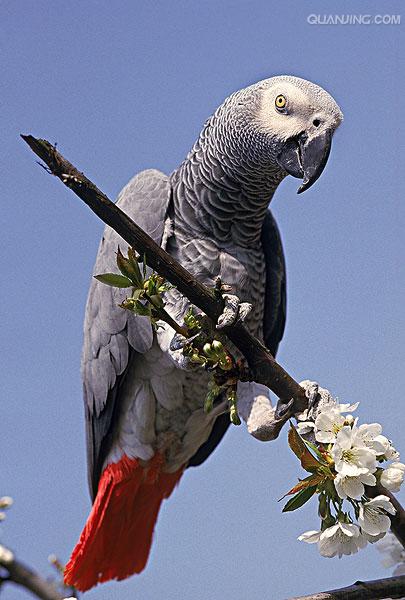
[318,522,363,558]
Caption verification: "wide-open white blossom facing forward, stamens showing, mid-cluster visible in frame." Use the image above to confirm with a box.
[332,425,377,477]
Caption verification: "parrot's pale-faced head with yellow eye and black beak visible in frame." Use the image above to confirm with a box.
[223,75,343,193]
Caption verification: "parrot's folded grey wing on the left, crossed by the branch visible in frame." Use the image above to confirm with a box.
[82,169,170,498]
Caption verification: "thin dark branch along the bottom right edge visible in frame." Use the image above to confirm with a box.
[290,575,405,600]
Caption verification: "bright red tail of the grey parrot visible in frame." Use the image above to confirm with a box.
[64,454,183,592]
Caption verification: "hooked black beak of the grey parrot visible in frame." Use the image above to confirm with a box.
[277,129,332,194]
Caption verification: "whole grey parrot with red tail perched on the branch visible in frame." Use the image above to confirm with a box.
[65,76,342,591]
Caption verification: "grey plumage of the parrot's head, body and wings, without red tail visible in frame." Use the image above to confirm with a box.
[83,76,342,493]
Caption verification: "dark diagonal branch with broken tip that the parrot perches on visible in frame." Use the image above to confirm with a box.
[21,135,405,547]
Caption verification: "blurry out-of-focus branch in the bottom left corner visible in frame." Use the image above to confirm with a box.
[0,547,65,600]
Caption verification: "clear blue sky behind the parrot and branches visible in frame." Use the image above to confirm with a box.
[0,0,405,600]
